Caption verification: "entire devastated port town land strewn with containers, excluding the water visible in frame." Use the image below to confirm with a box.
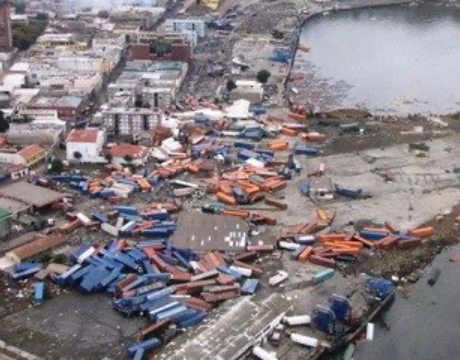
[0,0,460,360]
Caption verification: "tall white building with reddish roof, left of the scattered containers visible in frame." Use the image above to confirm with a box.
[66,129,106,163]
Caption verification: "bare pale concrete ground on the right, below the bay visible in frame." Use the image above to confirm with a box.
[282,138,460,230]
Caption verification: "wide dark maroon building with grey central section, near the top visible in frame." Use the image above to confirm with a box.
[131,31,192,63]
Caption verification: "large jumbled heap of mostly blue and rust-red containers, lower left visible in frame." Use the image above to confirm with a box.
[7,232,273,359]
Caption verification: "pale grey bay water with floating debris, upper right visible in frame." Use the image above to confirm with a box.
[294,4,460,114]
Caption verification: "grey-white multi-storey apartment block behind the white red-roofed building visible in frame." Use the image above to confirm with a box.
[102,108,162,135]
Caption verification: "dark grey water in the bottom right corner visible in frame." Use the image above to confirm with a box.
[344,246,460,360]
